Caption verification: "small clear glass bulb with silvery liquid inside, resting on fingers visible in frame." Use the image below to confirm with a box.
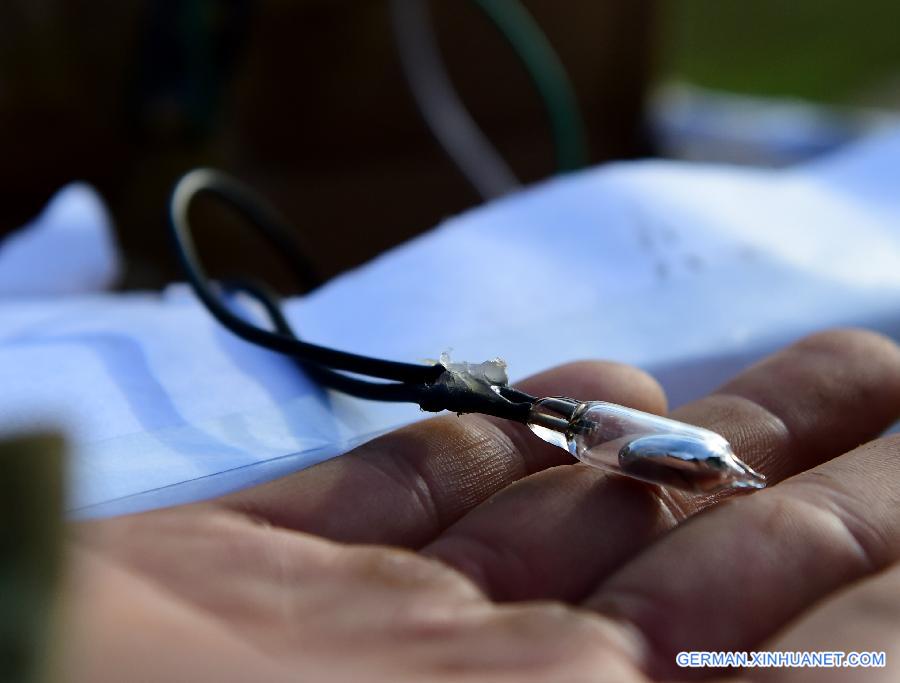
[528,398,766,493]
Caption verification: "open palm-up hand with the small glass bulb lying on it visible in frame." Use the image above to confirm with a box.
[58,330,900,683]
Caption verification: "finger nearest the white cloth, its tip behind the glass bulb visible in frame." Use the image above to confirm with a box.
[207,362,665,547]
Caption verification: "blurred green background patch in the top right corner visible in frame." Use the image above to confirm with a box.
[661,0,900,109]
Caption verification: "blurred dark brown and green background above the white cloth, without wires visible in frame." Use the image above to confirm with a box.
[0,0,900,287]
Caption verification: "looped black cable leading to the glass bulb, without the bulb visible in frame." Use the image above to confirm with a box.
[170,169,537,422]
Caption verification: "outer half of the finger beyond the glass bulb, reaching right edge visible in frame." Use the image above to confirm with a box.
[675,329,900,494]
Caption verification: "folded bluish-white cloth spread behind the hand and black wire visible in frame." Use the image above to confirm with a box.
[0,131,900,515]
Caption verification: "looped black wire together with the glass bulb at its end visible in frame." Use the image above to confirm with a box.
[170,169,765,492]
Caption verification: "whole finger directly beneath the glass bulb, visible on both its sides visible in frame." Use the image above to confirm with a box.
[425,332,900,600]
